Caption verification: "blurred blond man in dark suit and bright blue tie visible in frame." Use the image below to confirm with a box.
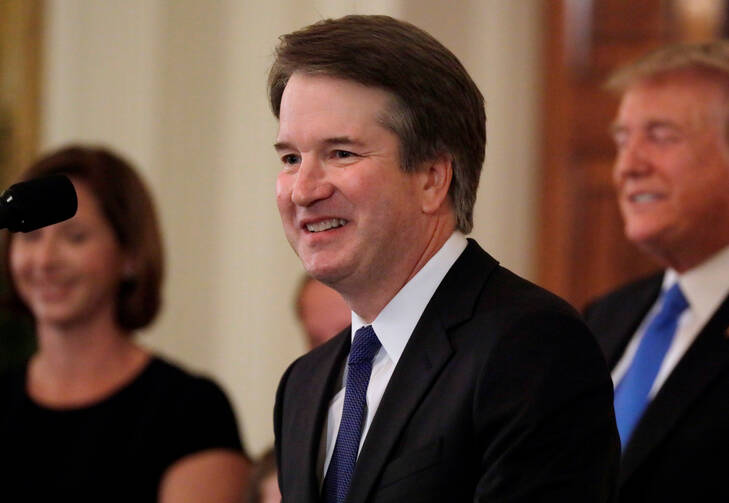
[586,42,729,502]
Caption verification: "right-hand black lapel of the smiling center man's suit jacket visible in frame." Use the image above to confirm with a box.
[347,240,497,503]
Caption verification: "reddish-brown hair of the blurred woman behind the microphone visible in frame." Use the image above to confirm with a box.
[4,146,164,330]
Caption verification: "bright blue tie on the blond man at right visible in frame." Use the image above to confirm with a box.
[615,283,688,450]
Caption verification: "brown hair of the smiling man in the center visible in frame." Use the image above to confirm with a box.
[268,15,486,233]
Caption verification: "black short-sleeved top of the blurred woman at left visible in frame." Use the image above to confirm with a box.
[0,358,243,502]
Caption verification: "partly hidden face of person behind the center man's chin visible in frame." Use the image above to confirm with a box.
[295,274,352,349]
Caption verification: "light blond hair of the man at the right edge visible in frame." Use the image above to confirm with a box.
[605,40,729,93]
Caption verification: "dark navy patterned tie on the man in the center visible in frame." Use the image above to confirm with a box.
[324,325,380,503]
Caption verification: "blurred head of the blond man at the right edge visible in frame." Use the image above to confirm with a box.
[608,41,729,273]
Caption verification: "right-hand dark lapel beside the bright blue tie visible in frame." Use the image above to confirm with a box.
[621,297,729,484]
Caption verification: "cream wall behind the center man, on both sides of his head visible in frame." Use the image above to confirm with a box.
[42,0,540,454]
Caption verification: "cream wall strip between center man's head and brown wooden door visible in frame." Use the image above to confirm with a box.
[402,0,542,277]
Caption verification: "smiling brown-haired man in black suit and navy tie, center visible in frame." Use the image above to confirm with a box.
[269,16,619,503]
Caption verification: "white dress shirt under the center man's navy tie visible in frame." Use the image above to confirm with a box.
[317,231,468,484]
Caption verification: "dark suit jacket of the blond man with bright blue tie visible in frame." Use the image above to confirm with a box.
[585,274,729,502]
